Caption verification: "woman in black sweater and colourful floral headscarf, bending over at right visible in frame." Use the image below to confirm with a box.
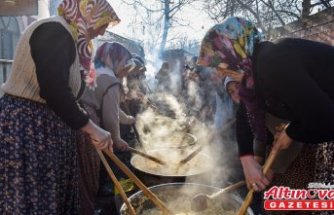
[198,17,334,198]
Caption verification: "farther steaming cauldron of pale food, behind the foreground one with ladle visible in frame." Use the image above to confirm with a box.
[130,148,213,186]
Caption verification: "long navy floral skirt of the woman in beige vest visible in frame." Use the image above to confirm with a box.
[0,95,79,215]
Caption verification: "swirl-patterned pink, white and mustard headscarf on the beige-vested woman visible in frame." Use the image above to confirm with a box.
[58,0,120,87]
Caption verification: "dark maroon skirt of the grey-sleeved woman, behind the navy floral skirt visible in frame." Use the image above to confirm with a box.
[78,105,100,215]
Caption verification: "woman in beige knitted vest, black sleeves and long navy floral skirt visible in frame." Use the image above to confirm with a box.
[0,0,119,214]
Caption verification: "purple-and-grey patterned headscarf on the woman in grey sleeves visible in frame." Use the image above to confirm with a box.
[94,42,135,76]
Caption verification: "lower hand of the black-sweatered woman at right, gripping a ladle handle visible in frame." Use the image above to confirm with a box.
[240,155,270,191]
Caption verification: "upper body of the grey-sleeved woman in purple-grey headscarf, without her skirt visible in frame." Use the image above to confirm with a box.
[81,42,135,151]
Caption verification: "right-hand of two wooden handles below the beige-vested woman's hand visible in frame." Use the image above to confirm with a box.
[104,149,174,215]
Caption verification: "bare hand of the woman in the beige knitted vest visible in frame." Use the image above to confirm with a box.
[81,120,113,152]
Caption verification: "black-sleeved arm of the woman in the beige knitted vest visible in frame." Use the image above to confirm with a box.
[29,22,88,129]
